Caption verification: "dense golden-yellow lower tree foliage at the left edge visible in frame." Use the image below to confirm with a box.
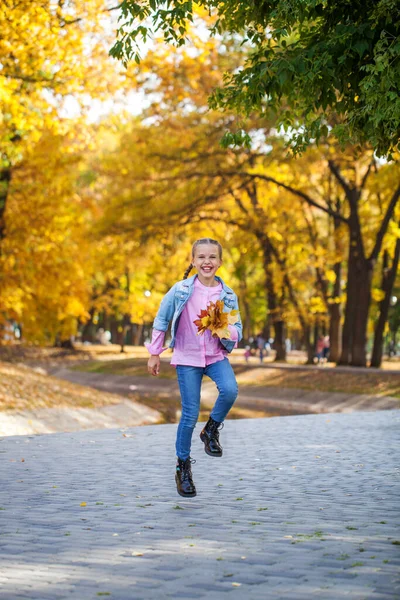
[0,127,92,344]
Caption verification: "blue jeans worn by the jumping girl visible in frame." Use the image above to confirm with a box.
[176,358,238,460]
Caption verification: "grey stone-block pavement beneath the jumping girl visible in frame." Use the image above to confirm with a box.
[0,411,400,600]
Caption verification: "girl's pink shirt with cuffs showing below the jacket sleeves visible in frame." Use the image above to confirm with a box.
[145,277,238,367]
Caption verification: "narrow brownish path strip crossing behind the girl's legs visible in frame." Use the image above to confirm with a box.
[52,368,400,414]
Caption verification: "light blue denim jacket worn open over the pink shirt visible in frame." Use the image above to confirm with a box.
[153,275,242,352]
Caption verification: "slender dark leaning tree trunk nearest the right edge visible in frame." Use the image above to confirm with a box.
[370,238,400,367]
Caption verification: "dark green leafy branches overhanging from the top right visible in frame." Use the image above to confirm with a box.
[111,0,400,155]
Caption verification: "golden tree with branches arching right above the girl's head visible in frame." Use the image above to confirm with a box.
[98,108,346,361]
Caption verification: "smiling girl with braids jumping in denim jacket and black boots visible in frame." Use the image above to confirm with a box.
[147,238,242,497]
